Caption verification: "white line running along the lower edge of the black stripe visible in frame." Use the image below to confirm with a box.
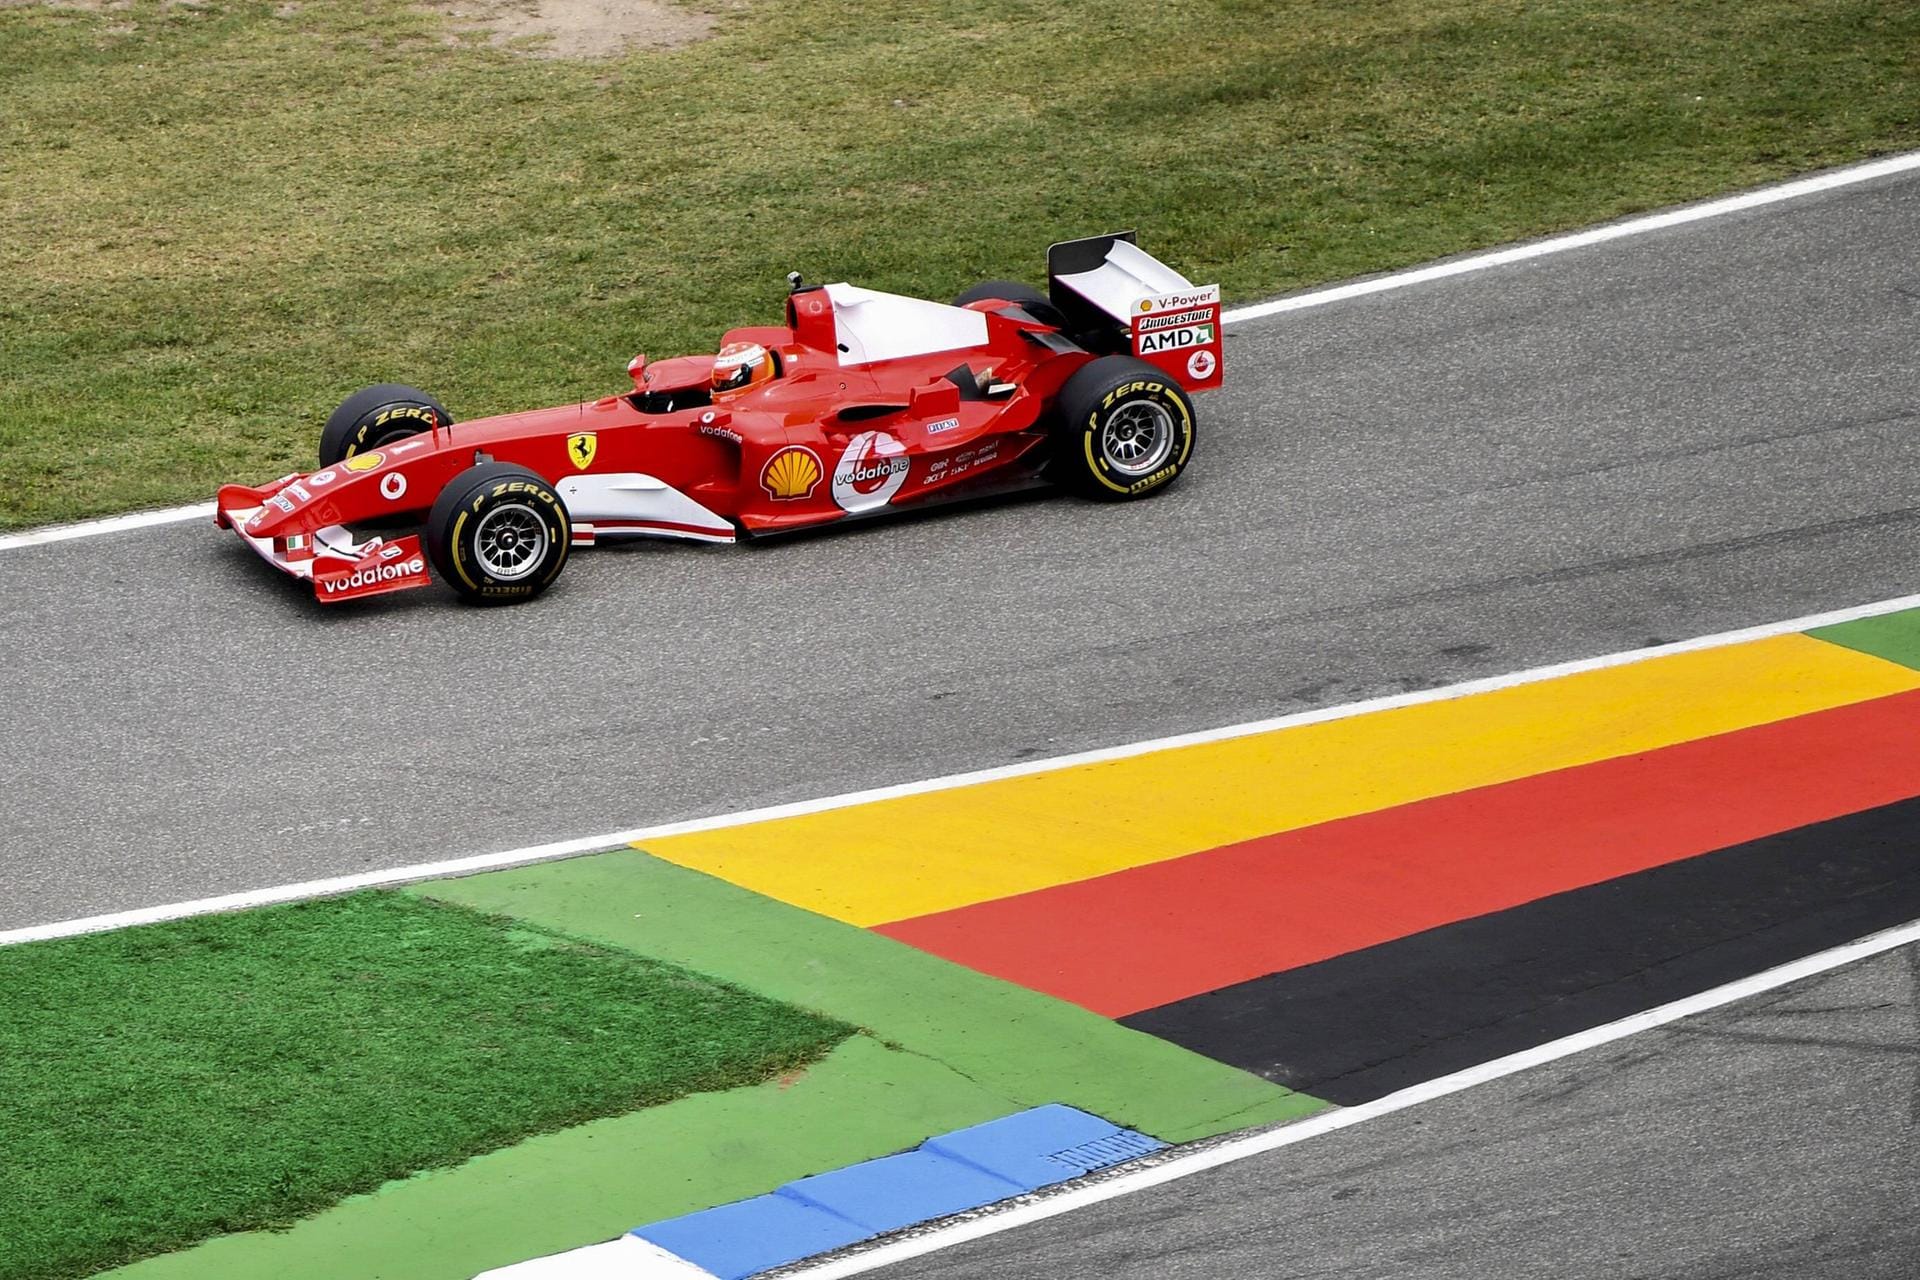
[783,909,1920,1280]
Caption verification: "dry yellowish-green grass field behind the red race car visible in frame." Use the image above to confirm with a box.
[0,0,1920,526]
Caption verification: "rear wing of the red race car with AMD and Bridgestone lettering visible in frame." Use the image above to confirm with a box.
[1046,230,1225,391]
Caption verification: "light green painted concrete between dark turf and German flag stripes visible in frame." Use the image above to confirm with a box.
[111,850,1327,1280]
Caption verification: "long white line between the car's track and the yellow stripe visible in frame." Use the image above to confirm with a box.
[0,595,1920,946]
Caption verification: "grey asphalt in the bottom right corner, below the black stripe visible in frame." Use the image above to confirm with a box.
[870,946,1920,1280]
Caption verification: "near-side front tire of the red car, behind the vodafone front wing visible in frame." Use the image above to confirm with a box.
[426,462,574,604]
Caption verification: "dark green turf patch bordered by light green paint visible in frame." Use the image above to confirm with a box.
[0,892,852,1280]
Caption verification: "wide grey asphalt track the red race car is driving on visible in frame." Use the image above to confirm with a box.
[0,165,1920,927]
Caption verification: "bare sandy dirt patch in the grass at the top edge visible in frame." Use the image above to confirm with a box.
[428,0,714,58]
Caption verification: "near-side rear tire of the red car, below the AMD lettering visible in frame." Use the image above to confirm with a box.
[1050,355,1194,503]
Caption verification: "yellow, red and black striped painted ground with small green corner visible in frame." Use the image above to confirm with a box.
[618,610,1920,1103]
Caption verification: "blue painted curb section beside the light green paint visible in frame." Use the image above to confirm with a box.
[630,1103,1165,1280]
